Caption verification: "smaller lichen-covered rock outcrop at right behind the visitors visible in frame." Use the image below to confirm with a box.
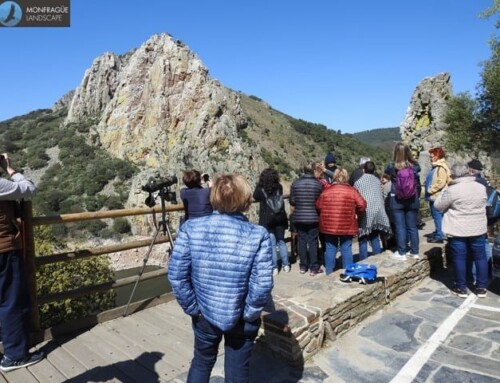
[400,73,492,181]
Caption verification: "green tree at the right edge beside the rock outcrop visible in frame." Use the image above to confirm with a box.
[445,0,500,153]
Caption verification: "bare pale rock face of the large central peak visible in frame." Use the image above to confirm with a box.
[66,34,265,222]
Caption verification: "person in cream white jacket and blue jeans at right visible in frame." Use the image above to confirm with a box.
[434,164,488,298]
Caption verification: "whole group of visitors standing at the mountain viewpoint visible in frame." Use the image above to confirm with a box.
[0,143,488,382]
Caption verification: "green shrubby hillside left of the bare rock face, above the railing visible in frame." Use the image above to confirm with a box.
[0,109,136,236]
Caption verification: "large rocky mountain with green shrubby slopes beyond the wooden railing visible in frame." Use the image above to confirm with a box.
[0,34,389,230]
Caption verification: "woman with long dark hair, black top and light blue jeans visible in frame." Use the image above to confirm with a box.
[253,168,290,275]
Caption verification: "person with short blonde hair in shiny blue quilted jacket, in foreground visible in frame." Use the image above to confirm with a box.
[168,174,273,383]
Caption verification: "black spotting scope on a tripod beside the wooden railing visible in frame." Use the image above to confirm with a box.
[123,175,177,316]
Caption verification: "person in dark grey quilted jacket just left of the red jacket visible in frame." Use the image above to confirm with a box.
[290,163,323,275]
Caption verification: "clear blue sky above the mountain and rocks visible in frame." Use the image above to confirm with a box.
[0,0,495,133]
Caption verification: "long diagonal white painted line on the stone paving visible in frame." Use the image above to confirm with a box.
[391,294,477,383]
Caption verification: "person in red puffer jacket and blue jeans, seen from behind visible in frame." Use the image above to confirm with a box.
[316,168,366,275]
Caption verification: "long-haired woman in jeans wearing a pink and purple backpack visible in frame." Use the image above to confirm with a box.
[385,142,421,260]
